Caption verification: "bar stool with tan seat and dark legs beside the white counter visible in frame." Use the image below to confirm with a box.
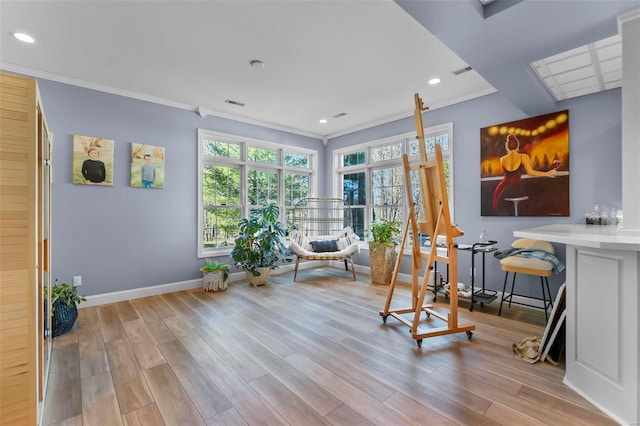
[498,238,555,320]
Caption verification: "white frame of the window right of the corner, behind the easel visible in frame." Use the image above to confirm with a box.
[333,122,455,247]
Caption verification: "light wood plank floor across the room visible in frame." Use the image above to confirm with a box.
[44,269,615,426]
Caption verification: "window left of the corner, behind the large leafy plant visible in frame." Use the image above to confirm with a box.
[198,129,315,257]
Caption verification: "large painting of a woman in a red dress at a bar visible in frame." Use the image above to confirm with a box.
[480,110,569,217]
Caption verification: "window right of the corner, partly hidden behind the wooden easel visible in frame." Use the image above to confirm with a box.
[336,123,453,246]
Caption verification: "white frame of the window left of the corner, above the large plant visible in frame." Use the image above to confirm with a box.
[196,129,318,258]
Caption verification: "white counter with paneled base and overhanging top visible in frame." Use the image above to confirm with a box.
[514,225,640,425]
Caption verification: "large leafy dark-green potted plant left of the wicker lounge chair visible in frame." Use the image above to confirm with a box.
[231,203,291,287]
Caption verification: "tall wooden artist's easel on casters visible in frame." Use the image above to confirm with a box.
[380,93,476,347]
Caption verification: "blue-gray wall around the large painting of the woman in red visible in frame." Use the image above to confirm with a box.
[327,89,622,295]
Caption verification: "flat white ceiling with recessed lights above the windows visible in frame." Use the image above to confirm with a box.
[0,0,495,138]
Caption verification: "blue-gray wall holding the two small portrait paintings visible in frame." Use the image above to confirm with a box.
[38,80,325,295]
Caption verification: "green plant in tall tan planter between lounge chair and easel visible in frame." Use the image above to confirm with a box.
[368,219,400,284]
